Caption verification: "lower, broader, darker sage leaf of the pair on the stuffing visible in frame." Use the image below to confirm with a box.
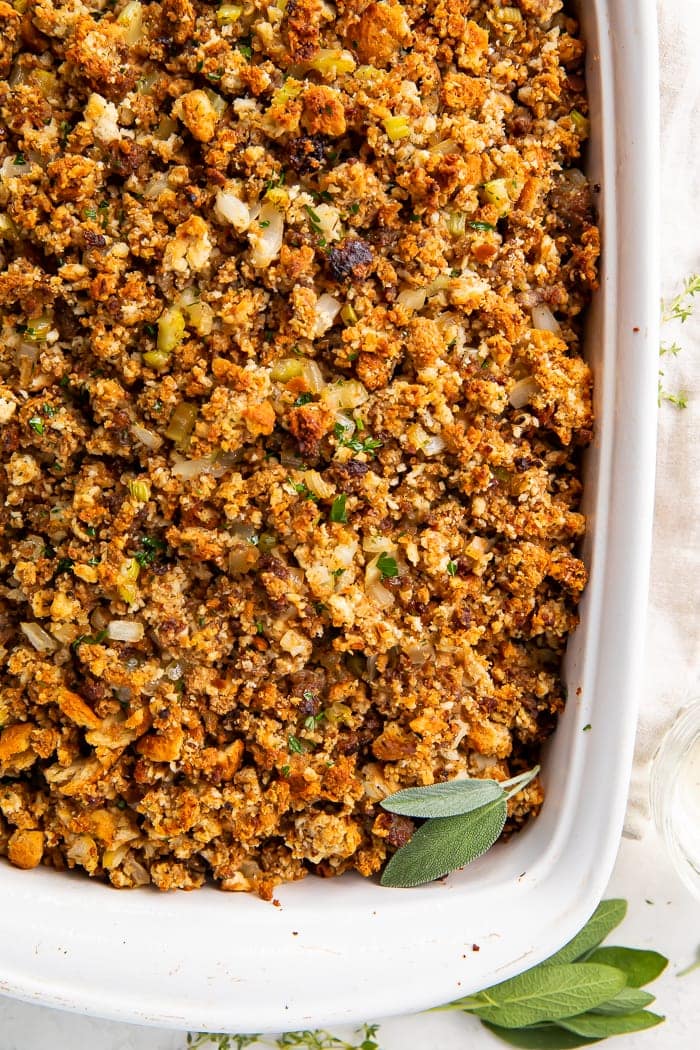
[381,797,505,886]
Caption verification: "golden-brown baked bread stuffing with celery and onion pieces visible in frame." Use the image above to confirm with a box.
[0,0,598,898]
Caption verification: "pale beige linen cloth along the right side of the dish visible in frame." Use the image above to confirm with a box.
[624,0,700,838]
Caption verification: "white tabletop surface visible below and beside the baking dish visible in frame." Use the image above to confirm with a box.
[0,833,700,1050]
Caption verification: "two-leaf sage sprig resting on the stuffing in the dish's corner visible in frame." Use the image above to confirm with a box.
[381,765,539,888]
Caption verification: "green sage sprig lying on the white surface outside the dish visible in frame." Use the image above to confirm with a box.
[438,901,669,1050]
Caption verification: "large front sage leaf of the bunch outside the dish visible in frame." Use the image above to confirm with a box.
[470,961,625,1028]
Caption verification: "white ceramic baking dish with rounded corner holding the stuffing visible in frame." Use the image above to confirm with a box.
[0,0,658,1032]
